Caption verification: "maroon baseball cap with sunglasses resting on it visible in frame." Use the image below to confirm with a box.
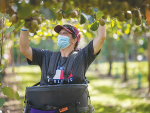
[54,24,80,43]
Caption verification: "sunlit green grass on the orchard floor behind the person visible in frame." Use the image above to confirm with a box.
[4,62,150,113]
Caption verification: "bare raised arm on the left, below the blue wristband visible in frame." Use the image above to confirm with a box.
[20,30,32,61]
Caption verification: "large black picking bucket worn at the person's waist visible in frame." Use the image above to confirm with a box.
[26,84,89,111]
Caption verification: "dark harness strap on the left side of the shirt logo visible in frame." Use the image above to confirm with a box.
[47,52,60,78]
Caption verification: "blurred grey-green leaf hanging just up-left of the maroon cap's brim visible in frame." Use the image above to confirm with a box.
[40,7,56,20]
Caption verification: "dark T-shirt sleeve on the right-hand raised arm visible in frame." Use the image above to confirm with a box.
[83,40,101,66]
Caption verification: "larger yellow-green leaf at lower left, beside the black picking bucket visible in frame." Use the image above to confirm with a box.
[1,86,19,100]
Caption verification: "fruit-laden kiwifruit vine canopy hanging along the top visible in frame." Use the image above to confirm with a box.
[0,0,150,33]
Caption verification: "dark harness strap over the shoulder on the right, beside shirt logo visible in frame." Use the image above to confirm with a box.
[63,51,78,84]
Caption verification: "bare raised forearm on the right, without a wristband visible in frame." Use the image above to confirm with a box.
[93,24,106,55]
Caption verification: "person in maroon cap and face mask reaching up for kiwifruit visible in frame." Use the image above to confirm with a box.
[20,24,106,113]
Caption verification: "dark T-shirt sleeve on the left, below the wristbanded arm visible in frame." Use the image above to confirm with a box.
[27,48,45,66]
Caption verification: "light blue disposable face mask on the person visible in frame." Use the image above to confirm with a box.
[57,35,70,49]
